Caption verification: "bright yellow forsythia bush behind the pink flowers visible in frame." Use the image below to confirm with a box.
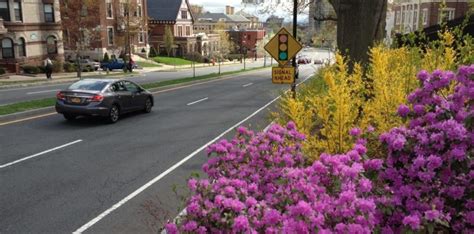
[273,31,474,159]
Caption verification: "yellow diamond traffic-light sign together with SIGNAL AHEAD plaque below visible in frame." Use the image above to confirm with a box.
[265,28,303,91]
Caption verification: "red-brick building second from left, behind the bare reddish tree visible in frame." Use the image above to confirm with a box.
[60,0,149,60]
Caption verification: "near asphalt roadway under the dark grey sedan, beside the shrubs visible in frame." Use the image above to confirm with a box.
[0,65,316,233]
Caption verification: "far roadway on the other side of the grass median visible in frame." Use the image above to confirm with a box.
[0,60,270,105]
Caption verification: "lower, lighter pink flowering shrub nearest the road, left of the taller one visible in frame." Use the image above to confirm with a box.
[167,122,382,233]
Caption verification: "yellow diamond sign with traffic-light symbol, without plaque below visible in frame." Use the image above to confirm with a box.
[265,28,303,66]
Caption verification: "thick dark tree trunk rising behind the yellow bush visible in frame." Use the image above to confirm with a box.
[329,0,387,63]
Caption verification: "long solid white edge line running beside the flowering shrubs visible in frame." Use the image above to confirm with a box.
[73,72,311,233]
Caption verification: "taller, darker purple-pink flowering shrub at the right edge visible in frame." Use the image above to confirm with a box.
[380,65,474,233]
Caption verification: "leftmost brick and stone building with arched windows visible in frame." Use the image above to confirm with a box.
[0,0,64,73]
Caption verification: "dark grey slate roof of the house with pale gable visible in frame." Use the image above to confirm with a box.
[147,0,194,21]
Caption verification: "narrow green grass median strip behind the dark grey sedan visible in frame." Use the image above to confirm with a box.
[0,67,270,116]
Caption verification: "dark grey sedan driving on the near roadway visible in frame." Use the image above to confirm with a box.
[56,79,154,123]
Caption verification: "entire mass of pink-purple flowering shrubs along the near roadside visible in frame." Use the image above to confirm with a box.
[165,66,474,233]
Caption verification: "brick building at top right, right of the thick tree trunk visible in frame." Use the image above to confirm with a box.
[392,0,470,33]
